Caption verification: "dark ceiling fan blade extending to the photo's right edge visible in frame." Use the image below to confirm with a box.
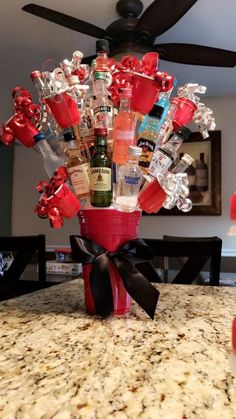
[153,44,236,67]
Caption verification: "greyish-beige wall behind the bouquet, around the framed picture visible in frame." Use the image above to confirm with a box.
[12,96,236,254]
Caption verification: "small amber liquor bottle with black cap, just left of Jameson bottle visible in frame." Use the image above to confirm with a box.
[64,132,90,206]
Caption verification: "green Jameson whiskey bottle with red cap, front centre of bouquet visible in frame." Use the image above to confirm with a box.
[90,128,112,207]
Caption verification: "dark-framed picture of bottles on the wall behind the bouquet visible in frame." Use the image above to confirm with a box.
[149,131,221,216]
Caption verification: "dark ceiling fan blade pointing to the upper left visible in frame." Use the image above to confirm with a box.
[22,3,106,39]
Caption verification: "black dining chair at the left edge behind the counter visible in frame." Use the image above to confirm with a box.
[0,234,55,300]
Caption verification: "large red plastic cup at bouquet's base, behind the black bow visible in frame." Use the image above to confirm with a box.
[78,209,141,315]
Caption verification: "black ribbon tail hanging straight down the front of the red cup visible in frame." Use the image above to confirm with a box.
[89,253,114,318]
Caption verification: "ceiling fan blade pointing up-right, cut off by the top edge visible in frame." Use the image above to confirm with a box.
[136,0,198,38]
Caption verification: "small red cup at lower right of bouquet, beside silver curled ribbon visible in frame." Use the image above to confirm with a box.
[138,179,166,214]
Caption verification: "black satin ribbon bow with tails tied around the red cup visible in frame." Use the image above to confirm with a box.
[70,235,159,319]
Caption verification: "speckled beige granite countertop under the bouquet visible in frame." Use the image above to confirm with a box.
[0,279,236,419]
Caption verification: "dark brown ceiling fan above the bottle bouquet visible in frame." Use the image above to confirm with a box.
[22,0,236,67]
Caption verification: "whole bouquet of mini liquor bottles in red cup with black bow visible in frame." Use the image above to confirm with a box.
[1,40,215,317]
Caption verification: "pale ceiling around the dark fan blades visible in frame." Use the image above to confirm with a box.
[0,0,236,119]
